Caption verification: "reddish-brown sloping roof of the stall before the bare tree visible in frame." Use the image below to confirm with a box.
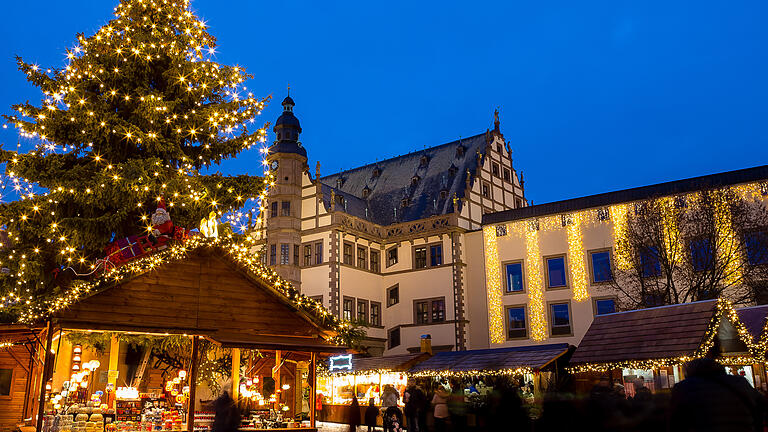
[570,300,717,365]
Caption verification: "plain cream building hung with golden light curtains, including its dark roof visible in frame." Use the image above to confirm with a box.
[467,166,768,348]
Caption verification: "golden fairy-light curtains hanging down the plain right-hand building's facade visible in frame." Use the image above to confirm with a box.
[483,182,768,347]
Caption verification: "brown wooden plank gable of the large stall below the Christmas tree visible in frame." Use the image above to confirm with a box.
[53,246,338,352]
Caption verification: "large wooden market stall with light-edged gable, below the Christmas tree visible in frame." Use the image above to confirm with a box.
[0,239,346,432]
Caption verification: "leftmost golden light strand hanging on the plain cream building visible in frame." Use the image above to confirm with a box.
[483,225,506,344]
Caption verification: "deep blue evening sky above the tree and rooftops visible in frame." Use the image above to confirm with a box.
[0,0,768,203]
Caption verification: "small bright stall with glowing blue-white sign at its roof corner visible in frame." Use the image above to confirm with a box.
[317,353,430,423]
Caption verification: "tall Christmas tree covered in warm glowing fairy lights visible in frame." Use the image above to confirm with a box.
[0,0,284,308]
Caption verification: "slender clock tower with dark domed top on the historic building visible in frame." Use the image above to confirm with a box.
[263,96,309,289]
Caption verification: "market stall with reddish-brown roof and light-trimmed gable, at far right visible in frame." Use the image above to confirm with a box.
[569,300,762,396]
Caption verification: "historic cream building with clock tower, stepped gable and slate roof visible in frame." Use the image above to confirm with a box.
[258,97,526,354]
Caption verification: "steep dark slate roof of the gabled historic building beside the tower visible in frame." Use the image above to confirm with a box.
[319,133,486,225]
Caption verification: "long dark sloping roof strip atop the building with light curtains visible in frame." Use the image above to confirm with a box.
[483,165,768,225]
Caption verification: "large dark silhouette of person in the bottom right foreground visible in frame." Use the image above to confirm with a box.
[669,359,766,432]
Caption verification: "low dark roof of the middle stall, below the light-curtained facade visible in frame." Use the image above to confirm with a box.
[408,343,569,373]
